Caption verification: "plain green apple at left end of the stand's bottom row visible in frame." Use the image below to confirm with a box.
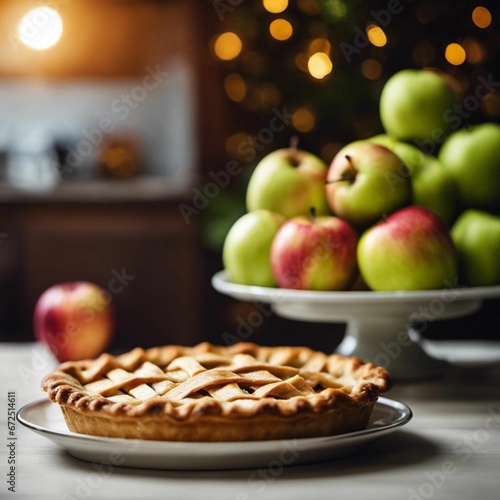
[222,210,285,287]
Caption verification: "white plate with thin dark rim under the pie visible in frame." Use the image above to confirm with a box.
[17,398,412,470]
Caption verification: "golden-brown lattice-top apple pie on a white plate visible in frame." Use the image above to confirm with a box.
[42,342,391,441]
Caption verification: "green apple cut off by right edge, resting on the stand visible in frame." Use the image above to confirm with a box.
[451,209,500,286]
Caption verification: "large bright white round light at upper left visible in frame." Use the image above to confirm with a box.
[17,7,63,50]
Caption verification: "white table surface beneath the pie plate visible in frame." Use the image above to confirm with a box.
[0,343,500,500]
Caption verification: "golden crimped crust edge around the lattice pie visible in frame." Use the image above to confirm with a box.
[42,342,391,422]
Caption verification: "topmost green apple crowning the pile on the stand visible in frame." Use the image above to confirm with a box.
[379,69,457,143]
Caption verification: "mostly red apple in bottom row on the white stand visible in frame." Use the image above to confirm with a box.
[271,210,357,290]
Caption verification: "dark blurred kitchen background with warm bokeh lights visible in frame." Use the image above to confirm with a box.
[0,0,500,350]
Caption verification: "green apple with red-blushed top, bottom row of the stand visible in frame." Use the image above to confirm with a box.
[357,206,457,291]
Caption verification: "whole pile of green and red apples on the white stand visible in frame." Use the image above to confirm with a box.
[222,69,500,291]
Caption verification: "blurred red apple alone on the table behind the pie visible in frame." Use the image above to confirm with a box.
[33,281,114,362]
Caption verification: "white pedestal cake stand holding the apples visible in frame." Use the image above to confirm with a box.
[212,271,500,380]
